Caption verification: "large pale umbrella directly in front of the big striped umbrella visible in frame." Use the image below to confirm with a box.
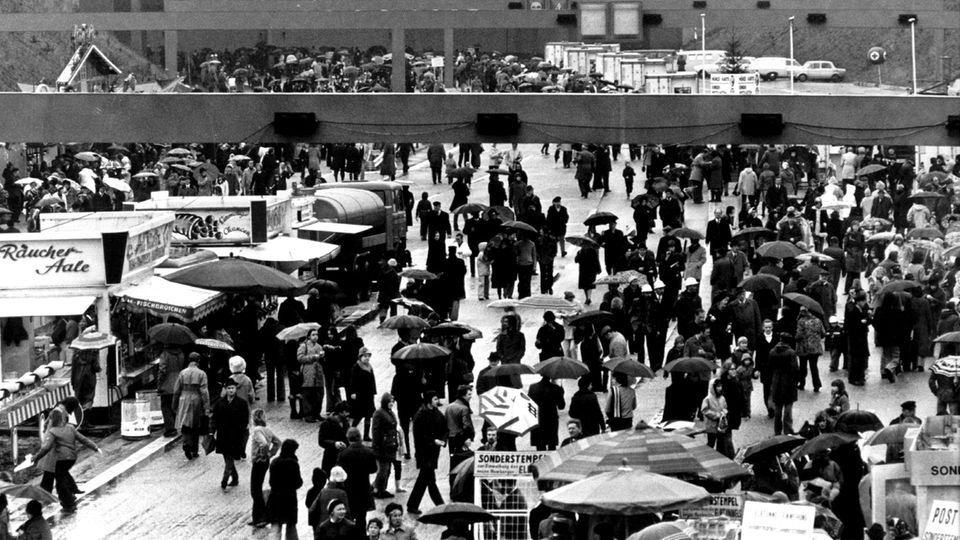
[543,466,710,516]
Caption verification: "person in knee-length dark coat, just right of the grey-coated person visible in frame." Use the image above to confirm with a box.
[210,377,250,489]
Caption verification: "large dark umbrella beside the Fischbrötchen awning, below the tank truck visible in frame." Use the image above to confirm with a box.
[166,258,307,295]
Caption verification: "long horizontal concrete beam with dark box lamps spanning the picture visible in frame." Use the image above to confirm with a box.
[0,94,957,146]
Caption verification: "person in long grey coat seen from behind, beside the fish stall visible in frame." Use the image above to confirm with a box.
[171,352,210,459]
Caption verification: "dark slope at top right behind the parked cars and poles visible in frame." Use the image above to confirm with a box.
[684,23,960,88]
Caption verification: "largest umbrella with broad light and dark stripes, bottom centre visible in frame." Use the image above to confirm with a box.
[534,429,750,484]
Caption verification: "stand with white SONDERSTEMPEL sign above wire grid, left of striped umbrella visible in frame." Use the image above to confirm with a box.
[473,451,551,540]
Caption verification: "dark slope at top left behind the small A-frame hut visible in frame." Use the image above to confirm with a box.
[0,0,162,92]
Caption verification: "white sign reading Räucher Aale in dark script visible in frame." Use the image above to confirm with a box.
[0,235,104,289]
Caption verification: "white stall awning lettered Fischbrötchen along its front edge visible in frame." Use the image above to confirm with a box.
[117,276,227,322]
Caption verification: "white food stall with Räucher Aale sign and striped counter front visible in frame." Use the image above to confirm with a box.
[0,212,174,456]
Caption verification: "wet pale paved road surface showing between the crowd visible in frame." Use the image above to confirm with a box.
[54,145,934,540]
